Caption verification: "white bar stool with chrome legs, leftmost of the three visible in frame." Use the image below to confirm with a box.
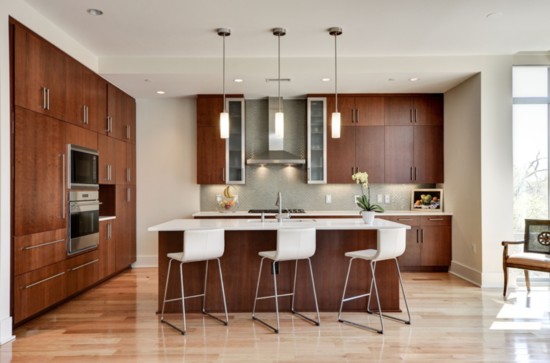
[160,229,229,335]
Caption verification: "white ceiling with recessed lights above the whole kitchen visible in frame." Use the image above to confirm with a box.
[25,0,550,97]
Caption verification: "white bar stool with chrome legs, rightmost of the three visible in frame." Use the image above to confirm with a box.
[338,228,411,334]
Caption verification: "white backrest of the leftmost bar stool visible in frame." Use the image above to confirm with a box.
[182,229,225,261]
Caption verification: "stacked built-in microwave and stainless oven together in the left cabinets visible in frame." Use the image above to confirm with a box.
[67,144,101,255]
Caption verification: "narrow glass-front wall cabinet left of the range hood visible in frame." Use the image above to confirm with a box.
[225,98,246,184]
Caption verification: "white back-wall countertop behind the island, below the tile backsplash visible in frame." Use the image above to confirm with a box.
[193,210,452,218]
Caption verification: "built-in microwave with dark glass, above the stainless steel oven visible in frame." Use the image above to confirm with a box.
[67,144,99,189]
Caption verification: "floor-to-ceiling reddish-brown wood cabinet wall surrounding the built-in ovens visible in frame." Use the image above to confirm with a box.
[10,19,136,325]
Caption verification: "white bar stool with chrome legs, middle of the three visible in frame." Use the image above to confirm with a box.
[252,228,321,334]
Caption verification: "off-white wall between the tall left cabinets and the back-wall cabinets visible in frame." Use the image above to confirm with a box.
[135,98,200,267]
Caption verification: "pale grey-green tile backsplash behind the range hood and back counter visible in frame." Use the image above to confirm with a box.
[200,99,434,211]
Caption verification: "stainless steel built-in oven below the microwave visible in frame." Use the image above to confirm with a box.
[67,190,101,255]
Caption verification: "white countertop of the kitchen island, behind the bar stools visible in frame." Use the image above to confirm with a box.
[147,218,411,232]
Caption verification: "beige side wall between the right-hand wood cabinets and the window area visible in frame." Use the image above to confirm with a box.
[444,74,482,285]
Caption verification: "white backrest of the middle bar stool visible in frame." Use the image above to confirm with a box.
[275,228,315,261]
